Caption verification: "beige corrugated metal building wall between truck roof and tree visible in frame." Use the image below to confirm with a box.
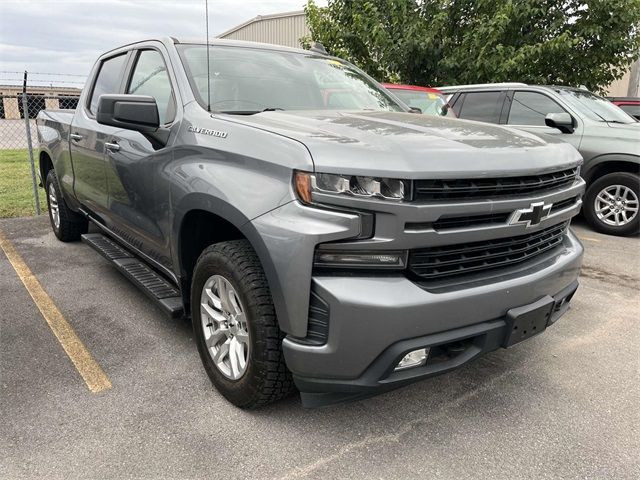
[218,10,309,47]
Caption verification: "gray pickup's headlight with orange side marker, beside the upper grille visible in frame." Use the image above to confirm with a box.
[293,172,409,203]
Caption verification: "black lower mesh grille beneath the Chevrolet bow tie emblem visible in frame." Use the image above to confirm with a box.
[409,222,569,280]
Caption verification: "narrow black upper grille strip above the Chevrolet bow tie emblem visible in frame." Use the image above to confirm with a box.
[414,168,578,201]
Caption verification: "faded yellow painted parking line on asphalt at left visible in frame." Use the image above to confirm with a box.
[0,230,111,393]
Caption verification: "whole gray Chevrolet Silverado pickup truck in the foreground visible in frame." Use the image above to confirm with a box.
[37,38,585,408]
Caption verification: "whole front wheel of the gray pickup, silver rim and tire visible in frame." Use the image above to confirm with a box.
[191,240,293,408]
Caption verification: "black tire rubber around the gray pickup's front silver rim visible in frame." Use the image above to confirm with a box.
[191,240,294,409]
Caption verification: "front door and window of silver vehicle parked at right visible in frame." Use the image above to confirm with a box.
[505,90,581,148]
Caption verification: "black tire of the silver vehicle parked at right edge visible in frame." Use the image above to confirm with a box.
[582,172,640,236]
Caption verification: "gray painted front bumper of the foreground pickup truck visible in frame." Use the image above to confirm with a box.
[283,232,583,406]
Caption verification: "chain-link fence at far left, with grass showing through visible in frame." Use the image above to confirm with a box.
[0,74,80,216]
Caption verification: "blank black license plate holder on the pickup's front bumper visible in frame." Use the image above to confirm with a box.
[503,295,554,348]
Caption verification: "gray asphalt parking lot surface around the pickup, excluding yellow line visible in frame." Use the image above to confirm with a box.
[0,216,640,479]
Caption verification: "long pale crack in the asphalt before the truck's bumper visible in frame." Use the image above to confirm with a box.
[278,369,520,480]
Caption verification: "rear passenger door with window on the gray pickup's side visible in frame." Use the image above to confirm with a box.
[69,52,129,218]
